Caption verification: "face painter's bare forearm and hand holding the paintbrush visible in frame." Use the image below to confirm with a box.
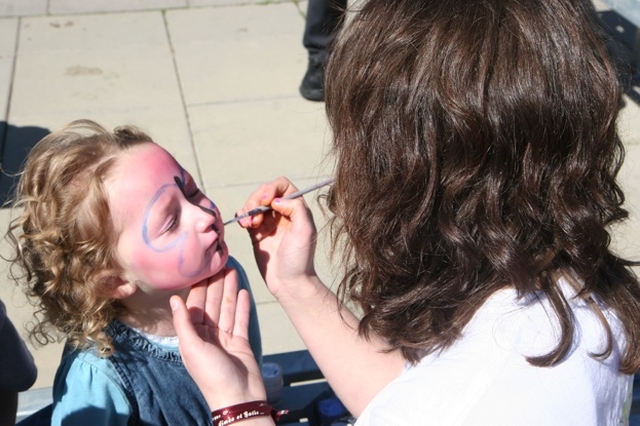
[235,178,405,417]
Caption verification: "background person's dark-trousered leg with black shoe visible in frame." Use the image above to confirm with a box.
[300,0,347,101]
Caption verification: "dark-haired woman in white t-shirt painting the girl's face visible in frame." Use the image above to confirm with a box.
[173,0,640,426]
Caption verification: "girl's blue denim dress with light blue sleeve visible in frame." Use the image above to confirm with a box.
[52,258,262,426]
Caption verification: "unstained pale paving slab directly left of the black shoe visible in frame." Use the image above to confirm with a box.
[166,3,307,105]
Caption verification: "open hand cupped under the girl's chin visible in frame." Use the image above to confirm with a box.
[171,269,266,410]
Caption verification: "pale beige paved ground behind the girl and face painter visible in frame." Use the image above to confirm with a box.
[0,0,640,396]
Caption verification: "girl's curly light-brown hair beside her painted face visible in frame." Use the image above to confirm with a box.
[7,120,151,355]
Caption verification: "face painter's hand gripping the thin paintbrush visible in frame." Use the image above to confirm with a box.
[239,177,316,298]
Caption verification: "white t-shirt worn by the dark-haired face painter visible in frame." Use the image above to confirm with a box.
[356,283,633,426]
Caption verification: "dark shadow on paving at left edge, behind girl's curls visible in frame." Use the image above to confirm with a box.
[0,121,51,206]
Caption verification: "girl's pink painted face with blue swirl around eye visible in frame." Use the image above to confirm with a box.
[106,142,229,291]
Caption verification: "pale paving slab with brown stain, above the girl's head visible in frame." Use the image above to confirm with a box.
[10,12,181,119]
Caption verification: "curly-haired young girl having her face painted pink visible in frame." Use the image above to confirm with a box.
[9,120,260,425]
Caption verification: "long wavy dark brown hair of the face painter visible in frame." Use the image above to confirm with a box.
[326,0,640,373]
